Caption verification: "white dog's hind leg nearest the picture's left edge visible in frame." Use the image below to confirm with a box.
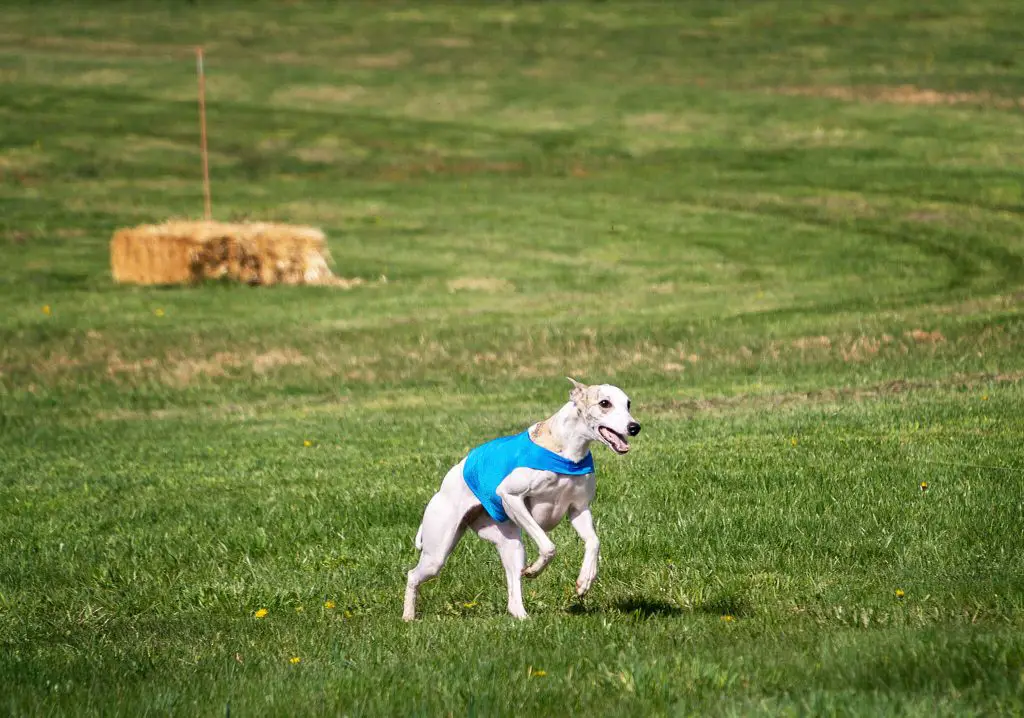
[401,463,480,621]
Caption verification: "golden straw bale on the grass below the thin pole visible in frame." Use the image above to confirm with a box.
[111,220,361,287]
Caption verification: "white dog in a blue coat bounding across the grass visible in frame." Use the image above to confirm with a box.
[402,379,640,621]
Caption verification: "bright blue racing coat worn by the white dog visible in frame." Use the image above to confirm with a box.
[462,429,594,521]
